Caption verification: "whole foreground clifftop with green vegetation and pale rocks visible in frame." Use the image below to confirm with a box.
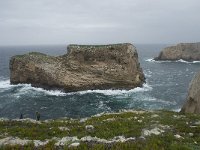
[0,111,200,150]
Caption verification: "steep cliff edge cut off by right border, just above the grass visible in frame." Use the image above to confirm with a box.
[181,72,200,114]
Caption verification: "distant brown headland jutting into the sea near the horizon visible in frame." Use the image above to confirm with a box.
[155,42,200,61]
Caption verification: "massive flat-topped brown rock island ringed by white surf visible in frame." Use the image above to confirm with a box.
[10,43,145,92]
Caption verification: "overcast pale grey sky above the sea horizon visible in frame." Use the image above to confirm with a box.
[0,0,200,45]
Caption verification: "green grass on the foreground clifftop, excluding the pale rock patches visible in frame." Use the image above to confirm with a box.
[0,111,200,150]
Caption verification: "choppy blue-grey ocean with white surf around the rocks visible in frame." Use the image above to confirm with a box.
[0,44,200,119]
